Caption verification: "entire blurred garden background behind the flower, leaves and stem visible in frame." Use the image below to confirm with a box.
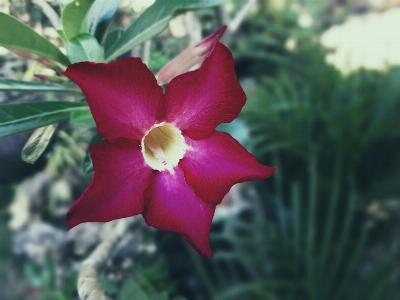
[0,0,400,300]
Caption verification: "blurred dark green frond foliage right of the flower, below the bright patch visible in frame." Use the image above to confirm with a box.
[158,5,400,300]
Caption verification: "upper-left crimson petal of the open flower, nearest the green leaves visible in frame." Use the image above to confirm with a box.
[64,57,163,141]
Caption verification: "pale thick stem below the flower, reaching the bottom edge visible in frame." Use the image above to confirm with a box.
[78,219,127,300]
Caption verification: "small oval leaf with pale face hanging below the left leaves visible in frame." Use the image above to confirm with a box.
[22,124,57,164]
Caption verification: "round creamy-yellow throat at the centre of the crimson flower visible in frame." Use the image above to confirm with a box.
[142,123,187,171]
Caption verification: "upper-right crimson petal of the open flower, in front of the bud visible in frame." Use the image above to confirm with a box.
[165,43,246,139]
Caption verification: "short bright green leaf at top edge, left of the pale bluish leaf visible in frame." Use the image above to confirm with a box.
[61,0,94,40]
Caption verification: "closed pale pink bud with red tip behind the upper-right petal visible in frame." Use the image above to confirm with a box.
[156,26,226,85]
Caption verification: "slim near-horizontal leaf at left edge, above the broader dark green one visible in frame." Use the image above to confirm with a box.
[0,78,82,94]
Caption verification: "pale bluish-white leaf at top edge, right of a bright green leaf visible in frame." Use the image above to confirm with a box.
[87,0,121,43]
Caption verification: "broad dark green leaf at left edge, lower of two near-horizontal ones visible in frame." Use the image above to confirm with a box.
[0,101,87,138]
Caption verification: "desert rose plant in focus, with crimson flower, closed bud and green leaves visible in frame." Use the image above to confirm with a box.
[0,0,275,270]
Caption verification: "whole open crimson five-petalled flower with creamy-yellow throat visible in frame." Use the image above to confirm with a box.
[64,43,275,256]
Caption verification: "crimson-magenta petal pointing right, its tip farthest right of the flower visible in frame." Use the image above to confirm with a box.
[179,131,275,203]
